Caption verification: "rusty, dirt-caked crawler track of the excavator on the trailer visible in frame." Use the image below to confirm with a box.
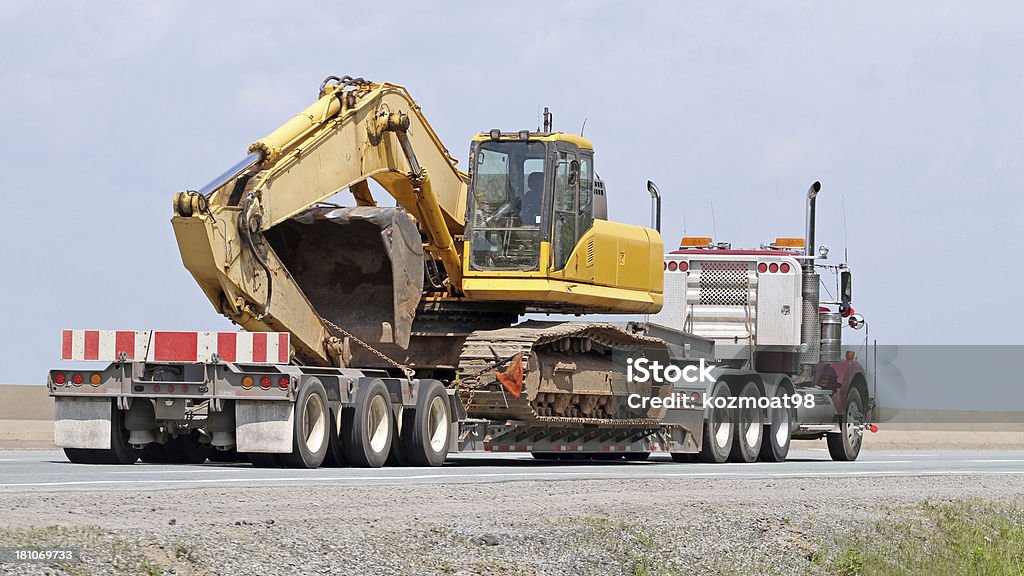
[459,321,669,426]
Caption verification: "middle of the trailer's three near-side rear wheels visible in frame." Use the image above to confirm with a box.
[341,380,394,468]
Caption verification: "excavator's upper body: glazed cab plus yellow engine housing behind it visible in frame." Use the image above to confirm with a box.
[462,130,663,314]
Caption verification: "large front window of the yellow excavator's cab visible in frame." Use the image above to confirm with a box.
[470,141,545,271]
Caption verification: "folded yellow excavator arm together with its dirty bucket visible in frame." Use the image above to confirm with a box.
[172,77,468,366]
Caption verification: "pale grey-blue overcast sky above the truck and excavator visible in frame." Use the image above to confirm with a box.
[0,1,1024,383]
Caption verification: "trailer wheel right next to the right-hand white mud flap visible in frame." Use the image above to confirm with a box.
[278,378,331,468]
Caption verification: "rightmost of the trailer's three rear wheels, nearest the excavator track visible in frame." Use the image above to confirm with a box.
[401,380,452,466]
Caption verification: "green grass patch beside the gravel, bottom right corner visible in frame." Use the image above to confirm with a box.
[827,500,1024,576]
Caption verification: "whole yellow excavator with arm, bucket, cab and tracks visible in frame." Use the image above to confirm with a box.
[172,76,663,421]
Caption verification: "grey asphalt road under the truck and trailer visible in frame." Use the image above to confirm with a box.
[0,450,1024,493]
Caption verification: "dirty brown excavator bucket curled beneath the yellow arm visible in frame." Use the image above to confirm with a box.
[264,206,423,348]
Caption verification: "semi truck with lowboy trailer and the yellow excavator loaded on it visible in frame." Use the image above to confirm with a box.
[47,76,872,468]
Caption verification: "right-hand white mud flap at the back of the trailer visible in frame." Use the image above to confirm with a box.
[234,400,295,454]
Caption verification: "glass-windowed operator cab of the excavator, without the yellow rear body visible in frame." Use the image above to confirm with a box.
[467,131,594,273]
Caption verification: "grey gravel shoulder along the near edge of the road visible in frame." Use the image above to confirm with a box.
[0,477,1024,576]
